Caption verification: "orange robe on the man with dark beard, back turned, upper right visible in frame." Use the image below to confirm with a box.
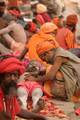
[56,27,75,50]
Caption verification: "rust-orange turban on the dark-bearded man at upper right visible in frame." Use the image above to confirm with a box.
[66,14,78,25]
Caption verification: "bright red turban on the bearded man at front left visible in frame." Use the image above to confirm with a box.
[0,57,25,74]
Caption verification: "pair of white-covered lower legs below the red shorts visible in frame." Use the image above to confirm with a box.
[17,87,43,109]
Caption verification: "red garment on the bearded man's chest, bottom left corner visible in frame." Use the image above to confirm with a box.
[0,88,20,120]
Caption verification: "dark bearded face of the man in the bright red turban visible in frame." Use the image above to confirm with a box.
[2,71,19,94]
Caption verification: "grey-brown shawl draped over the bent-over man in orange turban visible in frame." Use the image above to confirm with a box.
[55,48,80,100]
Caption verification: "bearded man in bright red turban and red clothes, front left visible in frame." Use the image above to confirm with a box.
[0,55,46,120]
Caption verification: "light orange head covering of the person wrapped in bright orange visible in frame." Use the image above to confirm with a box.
[40,22,58,34]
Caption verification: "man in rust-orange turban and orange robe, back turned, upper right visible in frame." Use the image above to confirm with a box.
[56,14,78,50]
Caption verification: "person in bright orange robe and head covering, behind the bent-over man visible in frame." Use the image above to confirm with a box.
[28,22,59,66]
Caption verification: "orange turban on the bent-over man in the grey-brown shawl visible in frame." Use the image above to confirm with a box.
[37,41,58,54]
